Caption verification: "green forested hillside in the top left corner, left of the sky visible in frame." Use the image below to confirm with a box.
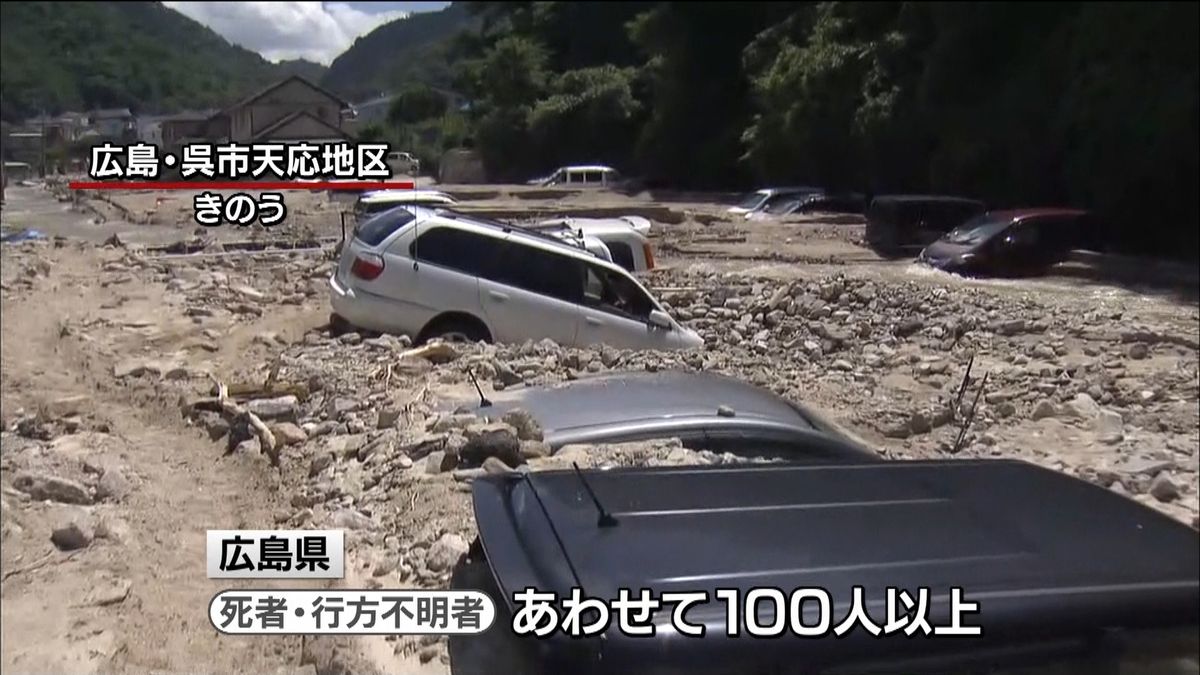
[0,2,288,120]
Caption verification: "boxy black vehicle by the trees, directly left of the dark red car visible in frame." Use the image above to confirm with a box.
[866,195,988,256]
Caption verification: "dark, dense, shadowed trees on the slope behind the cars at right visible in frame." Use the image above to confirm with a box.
[422,2,1200,256]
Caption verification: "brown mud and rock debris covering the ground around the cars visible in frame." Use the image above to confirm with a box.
[0,180,1200,673]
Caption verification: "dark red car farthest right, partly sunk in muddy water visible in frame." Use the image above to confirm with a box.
[917,209,1100,275]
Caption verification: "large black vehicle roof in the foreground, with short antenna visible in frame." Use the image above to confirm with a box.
[450,460,1200,675]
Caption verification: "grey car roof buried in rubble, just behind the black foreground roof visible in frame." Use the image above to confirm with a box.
[458,371,880,461]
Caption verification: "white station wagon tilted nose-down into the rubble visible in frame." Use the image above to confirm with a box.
[329,207,703,350]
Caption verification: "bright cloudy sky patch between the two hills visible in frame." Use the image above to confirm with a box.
[163,2,450,65]
